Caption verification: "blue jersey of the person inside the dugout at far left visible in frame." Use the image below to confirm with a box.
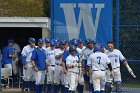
[2,46,13,64]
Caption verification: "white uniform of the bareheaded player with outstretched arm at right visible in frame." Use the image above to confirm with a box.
[105,49,125,82]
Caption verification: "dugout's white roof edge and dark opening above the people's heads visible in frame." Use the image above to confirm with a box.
[0,17,50,48]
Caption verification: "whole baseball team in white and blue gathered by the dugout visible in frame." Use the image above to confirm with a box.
[0,37,136,93]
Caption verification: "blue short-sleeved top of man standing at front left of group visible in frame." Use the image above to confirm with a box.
[31,47,47,70]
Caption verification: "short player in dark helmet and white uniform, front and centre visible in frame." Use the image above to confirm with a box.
[66,46,79,93]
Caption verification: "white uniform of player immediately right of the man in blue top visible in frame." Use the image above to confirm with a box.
[45,48,55,84]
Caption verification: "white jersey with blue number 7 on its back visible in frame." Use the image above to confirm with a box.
[87,52,110,71]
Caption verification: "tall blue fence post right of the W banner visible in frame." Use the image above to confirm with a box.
[116,0,120,49]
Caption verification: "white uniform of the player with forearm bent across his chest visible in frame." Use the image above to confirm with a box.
[54,49,64,85]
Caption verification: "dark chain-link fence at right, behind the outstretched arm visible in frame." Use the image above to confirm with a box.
[113,0,140,93]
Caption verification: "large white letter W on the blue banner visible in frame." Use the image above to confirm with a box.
[60,3,104,39]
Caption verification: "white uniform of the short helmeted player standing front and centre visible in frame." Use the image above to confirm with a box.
[66,54,79,91]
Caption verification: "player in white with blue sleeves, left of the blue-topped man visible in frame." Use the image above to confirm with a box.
[21,38,35,91]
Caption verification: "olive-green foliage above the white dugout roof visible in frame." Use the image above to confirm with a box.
[0,0,45,17]
